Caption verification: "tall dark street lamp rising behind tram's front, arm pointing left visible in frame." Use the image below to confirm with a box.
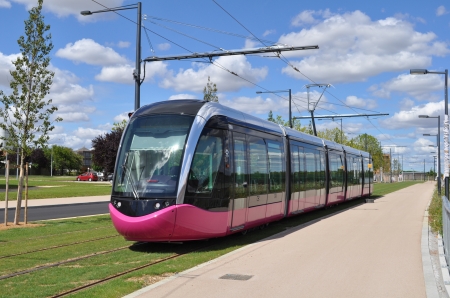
[80,2,142,110]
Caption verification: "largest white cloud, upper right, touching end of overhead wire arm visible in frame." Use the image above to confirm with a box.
[279,11,450,83]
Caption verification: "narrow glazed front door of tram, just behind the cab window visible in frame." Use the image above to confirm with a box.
[231,132,249,230]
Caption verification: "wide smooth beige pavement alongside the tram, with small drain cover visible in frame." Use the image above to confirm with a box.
[126,183,439,298]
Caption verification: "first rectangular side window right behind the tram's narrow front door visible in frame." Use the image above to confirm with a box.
[249,137,268,195]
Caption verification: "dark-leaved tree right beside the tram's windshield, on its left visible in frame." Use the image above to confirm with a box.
[92,128,123,173]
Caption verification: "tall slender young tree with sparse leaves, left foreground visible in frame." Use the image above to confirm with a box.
[0,0,62,225]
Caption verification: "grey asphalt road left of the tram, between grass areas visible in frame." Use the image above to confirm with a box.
[0,202,109,223]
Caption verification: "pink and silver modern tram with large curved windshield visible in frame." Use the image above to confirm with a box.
[109,100,372,242]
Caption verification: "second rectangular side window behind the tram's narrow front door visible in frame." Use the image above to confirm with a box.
[266,140,286,193]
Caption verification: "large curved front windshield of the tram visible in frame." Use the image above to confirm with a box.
[113,115,194,199]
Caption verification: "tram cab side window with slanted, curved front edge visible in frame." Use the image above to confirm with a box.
[188,129,223,194]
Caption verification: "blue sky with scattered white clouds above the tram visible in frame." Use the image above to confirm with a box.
[0,0,450,172]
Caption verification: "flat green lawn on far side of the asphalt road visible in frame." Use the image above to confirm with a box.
[0,176,111,201]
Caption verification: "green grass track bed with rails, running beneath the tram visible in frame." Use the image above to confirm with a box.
[0,181,428,297]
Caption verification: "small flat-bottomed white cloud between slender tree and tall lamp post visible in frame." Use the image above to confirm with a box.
[56,38,127,66]
